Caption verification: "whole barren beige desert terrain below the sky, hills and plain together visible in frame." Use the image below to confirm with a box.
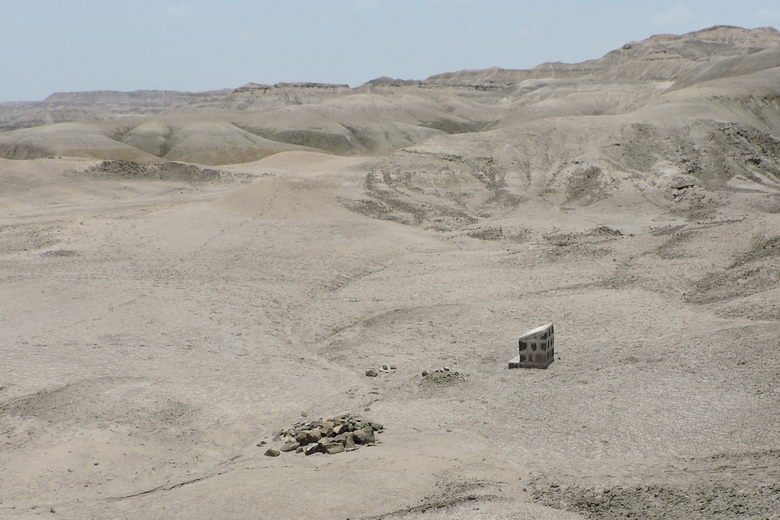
[0,26,780,520]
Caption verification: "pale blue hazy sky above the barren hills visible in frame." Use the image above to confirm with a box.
[0,0,780,101]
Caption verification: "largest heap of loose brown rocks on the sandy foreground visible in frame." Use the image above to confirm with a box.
[265,414,384,457]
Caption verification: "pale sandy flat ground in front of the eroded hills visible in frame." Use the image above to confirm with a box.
[0,152,780,519]
